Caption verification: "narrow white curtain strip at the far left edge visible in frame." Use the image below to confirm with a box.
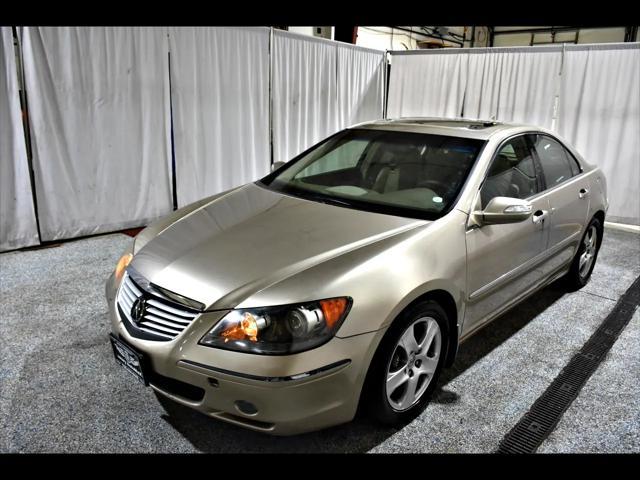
[0,27,39,252]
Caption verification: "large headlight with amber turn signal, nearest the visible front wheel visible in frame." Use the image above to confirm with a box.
[200,297,351,355]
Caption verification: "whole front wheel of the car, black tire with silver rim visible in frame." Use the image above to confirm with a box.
[365,301,448,425]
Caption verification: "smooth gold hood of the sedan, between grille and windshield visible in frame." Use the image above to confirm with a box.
[131,184,427,309]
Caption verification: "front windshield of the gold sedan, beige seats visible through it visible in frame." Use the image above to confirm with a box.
[261,129,484,219]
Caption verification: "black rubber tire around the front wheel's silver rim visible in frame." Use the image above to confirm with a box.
[363,300,449,425]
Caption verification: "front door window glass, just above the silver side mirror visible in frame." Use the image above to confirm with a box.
[480,136,539,208]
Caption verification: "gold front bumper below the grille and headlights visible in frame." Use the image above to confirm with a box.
[106,275,384,435]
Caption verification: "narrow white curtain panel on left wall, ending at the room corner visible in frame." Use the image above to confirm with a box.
[336,43,385,129]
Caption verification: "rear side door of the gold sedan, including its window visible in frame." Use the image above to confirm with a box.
[529,134,591,275]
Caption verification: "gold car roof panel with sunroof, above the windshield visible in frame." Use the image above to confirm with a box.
[351,117,544,140]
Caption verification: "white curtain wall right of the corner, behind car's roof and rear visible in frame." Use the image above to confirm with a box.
[387,43,640,225]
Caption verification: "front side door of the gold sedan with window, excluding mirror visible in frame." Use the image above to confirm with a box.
[462,135,549,336]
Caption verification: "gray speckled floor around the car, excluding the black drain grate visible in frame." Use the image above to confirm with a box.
[0,230,640,452]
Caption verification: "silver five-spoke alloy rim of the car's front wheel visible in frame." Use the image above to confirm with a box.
[385,317,442,411]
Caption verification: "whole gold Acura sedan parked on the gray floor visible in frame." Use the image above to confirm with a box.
[106,118,608,435]
